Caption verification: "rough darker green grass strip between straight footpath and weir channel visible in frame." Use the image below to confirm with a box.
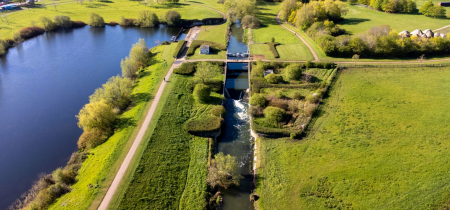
[117,74,222,209]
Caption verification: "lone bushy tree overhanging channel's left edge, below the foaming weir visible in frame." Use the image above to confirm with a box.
[206,152,242,189]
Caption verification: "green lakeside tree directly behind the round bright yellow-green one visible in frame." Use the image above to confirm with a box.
[89,76,133,110]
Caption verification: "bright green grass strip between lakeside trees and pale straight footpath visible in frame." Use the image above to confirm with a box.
[50,44,175,209]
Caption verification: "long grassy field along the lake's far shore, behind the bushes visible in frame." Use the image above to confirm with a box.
[0,0,222,38]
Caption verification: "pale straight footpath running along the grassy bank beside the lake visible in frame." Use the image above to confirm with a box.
[98,60,183,210]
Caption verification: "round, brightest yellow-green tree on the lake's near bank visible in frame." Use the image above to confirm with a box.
[76,100,116,132]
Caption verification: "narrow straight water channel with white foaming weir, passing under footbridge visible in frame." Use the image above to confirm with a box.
[217,21,253,210]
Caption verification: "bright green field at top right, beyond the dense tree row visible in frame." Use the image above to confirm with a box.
[339,6,450,34]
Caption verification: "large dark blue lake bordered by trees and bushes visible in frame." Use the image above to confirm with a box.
[0,26,183,209]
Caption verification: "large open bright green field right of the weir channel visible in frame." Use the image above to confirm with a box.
[257,68,450,209]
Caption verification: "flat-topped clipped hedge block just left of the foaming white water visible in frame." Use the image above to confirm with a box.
[184,116,223,136]
